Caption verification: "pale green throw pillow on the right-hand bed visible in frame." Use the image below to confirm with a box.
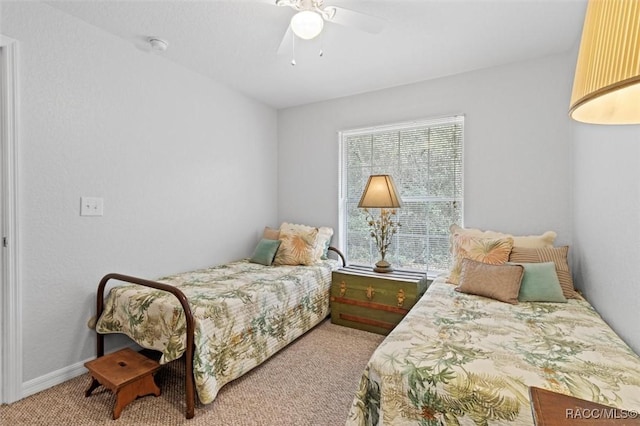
[514,262,567,303]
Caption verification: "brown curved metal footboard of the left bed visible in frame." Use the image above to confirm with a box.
[96,274,196,419]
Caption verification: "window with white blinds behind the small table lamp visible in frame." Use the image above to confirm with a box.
[340,116,464,274]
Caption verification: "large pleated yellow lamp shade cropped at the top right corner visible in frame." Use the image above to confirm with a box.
[569,0,640,124]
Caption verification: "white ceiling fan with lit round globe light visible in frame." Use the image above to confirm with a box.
[275,0,385,54]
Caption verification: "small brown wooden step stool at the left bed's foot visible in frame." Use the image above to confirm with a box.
[84,348,160,420]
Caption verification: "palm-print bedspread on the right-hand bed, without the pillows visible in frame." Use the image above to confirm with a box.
[347,279,640,426]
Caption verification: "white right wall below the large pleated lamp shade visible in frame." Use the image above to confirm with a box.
[573,124,640,353]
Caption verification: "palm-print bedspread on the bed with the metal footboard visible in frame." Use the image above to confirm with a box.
[96,260,338,404]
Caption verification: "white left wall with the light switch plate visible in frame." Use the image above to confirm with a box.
[0,2,278,381]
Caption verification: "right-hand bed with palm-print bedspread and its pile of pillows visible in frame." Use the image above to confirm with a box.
[347,225,640,426]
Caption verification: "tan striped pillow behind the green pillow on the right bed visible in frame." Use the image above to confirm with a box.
[509,246,579,299]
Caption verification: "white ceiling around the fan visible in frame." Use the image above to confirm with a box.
[47,0,586,108]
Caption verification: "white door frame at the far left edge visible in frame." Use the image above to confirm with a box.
[0,34,22,403]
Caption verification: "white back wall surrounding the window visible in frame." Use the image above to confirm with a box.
[278,55,573,244]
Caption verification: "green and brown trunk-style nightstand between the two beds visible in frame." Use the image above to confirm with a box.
[331,266,430,334]
